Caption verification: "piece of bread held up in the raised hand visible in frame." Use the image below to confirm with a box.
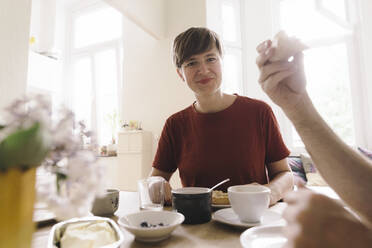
[269,31,308,62]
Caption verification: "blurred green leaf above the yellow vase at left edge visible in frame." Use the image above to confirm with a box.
[0,123,50,169]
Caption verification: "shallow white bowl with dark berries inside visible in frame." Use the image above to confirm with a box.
[119,210,185,242]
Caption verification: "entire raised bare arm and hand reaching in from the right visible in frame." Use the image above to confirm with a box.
[256,41,372,223]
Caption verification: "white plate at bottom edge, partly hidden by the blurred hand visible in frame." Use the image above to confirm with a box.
[240,226,287,248]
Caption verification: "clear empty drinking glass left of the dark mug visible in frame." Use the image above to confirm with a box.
[138,176,165,210]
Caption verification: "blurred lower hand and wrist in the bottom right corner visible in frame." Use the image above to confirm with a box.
[283,189,372,248]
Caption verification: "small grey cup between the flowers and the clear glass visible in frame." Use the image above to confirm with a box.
[92,189,120,216]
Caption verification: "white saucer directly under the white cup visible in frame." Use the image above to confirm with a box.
[212,208,285,228]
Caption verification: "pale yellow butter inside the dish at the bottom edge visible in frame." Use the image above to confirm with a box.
[60,220,118,248]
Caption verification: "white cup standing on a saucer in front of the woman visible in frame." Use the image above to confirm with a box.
[227,184,271,223]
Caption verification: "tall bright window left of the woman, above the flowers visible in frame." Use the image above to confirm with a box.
[69,4,122,145]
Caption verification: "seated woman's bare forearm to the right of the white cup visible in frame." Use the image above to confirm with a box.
[266,171,293,205]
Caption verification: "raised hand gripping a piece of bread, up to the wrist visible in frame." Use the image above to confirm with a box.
[256,40,307,111]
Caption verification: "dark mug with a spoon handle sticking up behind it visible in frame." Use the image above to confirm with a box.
[172,187,212,224]
